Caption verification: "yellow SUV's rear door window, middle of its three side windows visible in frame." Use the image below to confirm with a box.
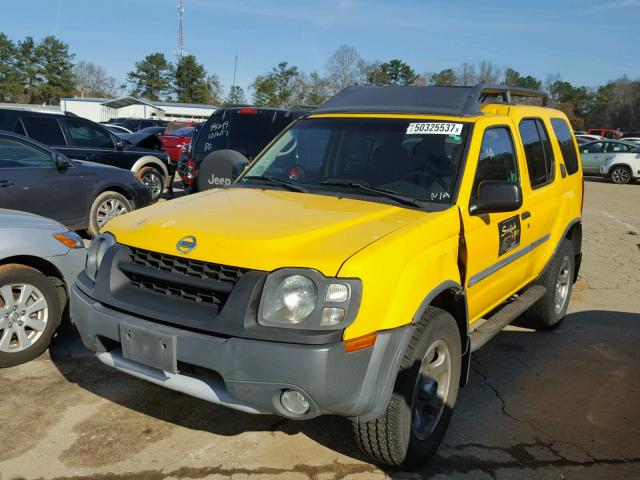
[519,118,555,188]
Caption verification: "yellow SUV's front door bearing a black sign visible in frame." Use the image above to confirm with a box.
[458,125,530,323]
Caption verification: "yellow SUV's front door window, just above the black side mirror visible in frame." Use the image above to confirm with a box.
[472,127,518,200]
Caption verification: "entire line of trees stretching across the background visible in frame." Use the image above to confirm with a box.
[0,33,640,131]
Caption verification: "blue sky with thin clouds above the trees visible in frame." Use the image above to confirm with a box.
[0,0,640,95]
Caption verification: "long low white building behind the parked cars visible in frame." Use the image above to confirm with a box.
[60,97,218,122]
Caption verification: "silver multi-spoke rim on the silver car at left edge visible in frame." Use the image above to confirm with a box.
[0,283,49,353]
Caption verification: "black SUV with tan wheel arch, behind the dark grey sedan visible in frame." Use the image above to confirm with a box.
[0,108,169,200]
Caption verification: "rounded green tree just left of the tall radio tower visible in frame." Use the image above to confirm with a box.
[127,53,175,100]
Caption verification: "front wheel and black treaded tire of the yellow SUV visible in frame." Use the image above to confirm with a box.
[353,307,462,469]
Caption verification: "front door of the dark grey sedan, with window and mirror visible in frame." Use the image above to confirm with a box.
[0,137,86,227]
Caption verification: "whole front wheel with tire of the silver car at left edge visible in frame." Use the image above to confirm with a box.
[0,265,61,367]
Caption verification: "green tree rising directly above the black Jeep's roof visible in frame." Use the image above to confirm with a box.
[251,62,299,107]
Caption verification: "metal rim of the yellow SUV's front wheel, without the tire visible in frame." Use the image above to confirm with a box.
[411,340,451,440]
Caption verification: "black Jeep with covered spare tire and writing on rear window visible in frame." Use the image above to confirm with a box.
[178,106,309,193]
